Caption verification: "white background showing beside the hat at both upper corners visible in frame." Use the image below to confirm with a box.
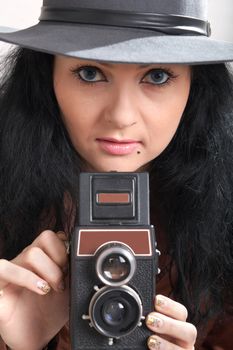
[0,0,233,56]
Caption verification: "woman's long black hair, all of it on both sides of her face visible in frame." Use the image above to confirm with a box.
[0,48,233,323]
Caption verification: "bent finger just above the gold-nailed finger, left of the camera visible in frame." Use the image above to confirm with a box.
[14,246,65,291]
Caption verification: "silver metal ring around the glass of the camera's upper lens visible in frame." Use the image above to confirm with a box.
[96,242,136,286]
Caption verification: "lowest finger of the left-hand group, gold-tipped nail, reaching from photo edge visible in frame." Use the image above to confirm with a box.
[0,259,51,297]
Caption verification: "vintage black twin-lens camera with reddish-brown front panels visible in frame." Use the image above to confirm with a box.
[70,172,158,350]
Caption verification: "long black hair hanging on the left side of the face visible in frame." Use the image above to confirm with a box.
[0,48,79,259]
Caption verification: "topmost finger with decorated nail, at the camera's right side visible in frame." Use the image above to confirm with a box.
[155,295,188,321]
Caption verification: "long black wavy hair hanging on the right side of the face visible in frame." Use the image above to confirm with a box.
[151,64,233,324]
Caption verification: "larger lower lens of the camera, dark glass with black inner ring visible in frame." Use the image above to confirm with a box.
[89,286,142,338]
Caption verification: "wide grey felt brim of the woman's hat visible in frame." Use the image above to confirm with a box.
[0,22,233,64]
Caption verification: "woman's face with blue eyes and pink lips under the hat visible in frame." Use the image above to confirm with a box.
[54,56,191,172]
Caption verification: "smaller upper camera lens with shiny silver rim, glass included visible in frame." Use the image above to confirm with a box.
[96,242,136,286]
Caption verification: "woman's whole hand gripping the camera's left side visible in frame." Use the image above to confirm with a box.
[0,230,69,350]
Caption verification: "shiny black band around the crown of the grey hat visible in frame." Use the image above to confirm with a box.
[39,6,211,36]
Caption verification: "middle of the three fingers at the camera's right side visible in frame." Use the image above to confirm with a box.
[146,312,197,349]
